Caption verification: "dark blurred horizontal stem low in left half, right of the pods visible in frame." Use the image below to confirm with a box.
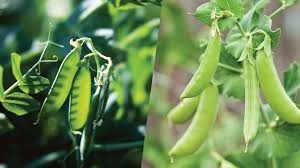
[93,141,144,151]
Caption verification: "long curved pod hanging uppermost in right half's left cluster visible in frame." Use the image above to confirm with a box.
[180,20,221,99]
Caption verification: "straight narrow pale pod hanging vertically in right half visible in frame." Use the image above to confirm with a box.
[243,59,260,147]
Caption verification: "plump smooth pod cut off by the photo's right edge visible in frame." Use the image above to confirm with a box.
[256,50,300,124]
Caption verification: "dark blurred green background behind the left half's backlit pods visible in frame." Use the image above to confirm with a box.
[0,0,161,168]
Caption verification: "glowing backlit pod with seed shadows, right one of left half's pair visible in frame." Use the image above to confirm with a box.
[69,60,92,131]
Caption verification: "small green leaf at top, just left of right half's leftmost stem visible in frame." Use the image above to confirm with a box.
[193,2,215,26]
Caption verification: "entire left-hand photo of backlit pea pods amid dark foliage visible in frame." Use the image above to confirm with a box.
[0,0,160,168]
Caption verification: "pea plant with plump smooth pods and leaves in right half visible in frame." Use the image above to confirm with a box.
[167,0,300,168]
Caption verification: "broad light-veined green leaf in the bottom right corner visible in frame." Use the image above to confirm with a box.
[249,124,300,159]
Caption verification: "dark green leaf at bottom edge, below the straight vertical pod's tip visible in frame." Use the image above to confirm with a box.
[225,153,267,168]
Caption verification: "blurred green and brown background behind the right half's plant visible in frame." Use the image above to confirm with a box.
[142,0,300,168]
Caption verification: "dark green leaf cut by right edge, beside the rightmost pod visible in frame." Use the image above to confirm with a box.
[283,62,300,97]
